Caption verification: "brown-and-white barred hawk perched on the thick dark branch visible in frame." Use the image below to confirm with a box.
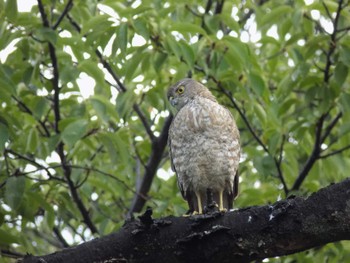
[167,78,240,214]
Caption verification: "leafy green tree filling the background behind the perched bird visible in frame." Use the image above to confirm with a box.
[0,0,350,262]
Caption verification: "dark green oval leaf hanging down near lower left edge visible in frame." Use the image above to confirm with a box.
[5,176,26,211]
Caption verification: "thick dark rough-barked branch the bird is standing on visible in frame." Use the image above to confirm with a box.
[23,179,350,263]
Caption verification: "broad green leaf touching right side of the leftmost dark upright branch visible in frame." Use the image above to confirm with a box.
[61,120,88,147]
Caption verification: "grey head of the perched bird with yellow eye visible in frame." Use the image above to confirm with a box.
[168,78,216,110]
